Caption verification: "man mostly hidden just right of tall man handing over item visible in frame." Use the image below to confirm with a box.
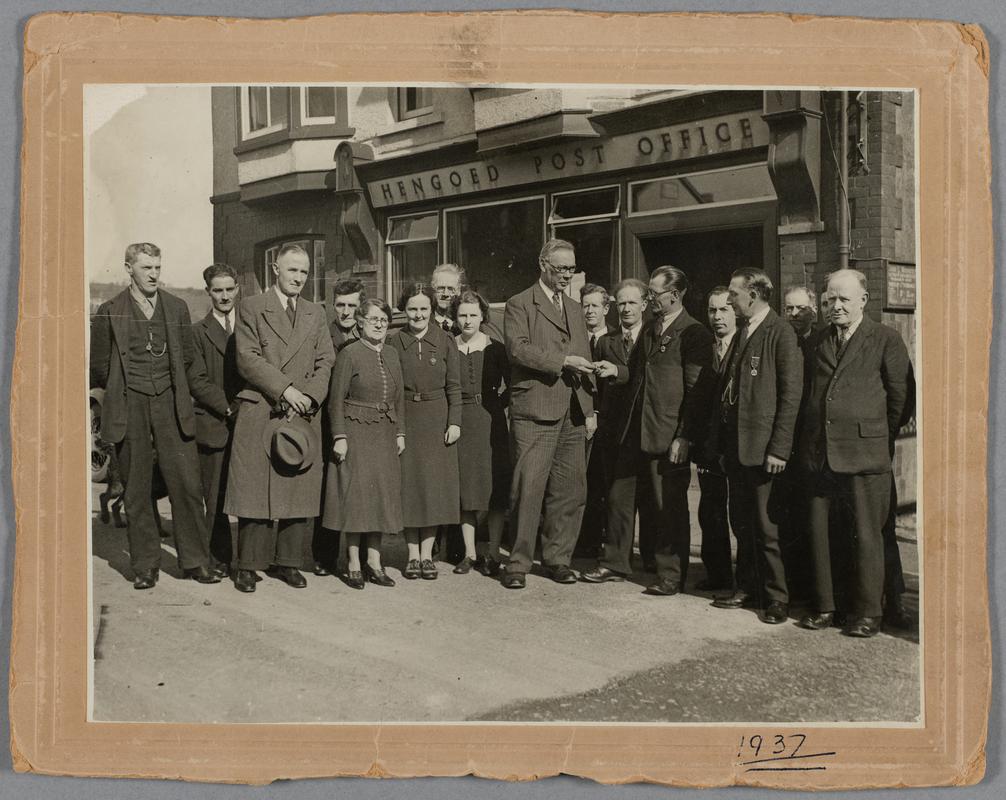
[573,284,611,558]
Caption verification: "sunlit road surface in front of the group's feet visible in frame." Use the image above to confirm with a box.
[93,481,919,723]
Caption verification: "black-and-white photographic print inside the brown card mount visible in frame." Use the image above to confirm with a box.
[86,84,921,727]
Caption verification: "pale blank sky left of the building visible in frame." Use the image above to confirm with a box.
[83,85,213,287]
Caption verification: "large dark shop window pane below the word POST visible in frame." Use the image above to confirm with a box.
[445,197,545,303]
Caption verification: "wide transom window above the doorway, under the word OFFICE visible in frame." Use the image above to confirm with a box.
[629,164,776,216]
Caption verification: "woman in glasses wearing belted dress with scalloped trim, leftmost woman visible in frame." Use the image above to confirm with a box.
[323,298,405,589]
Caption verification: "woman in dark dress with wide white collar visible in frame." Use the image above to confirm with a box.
[454,291,510,576]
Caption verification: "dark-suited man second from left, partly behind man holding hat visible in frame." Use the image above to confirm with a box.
[192,264,241,572]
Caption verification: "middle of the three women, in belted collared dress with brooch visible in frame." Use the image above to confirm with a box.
[388,284,461,581]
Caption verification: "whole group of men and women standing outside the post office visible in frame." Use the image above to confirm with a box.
[91,239,913,637]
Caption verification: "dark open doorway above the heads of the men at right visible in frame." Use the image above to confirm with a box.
[639,225,766,322]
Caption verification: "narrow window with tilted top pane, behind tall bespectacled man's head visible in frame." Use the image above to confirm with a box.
[548,186,621,287]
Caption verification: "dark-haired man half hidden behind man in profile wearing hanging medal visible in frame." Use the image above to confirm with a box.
[693,286,737,592]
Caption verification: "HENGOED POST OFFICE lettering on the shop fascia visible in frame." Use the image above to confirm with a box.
[367,113,769,208]
